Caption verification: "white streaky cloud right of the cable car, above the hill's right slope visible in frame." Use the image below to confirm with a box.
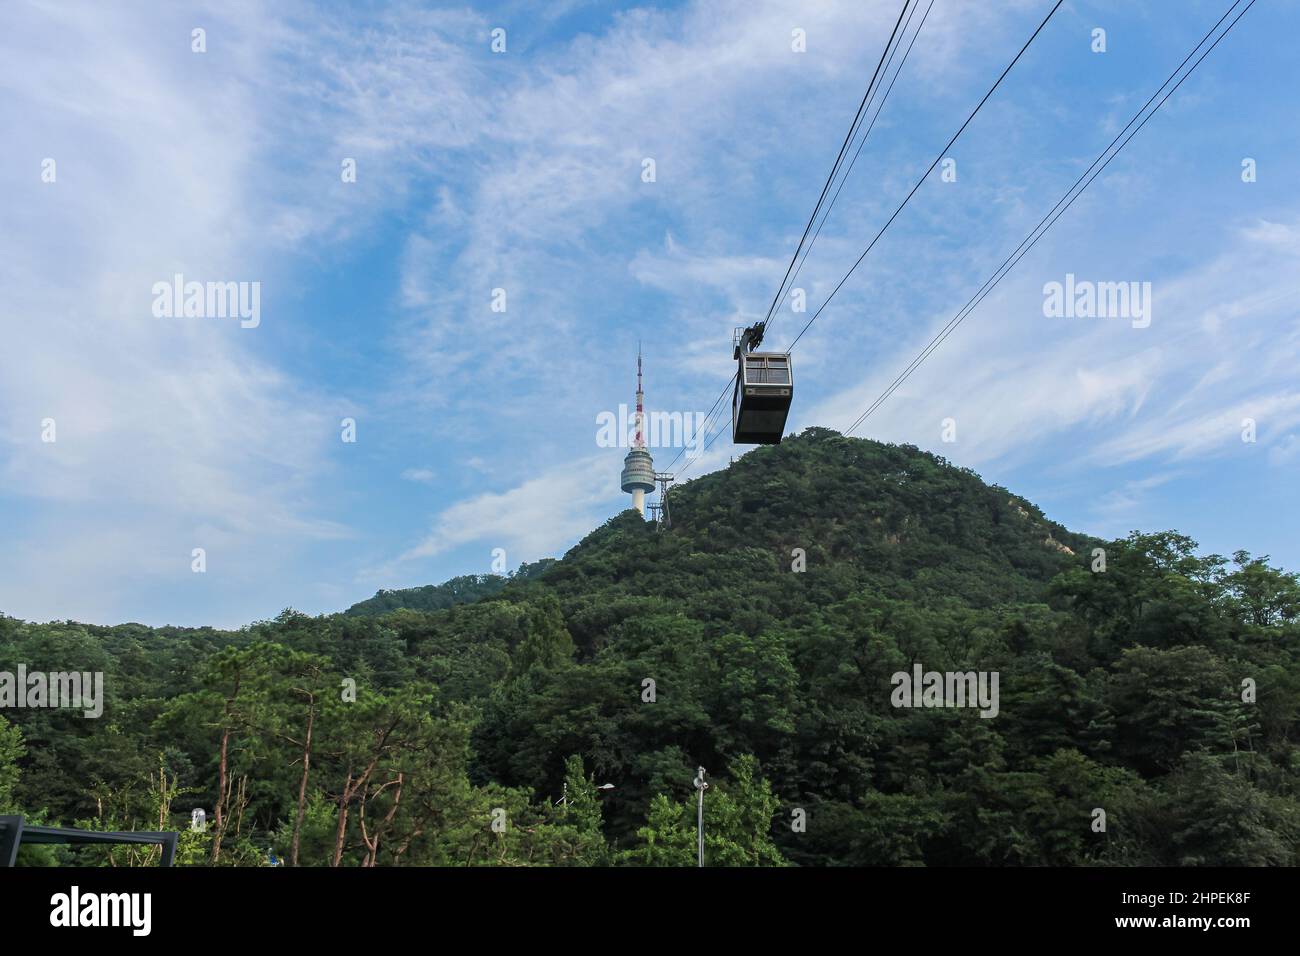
[802,214,1300,467]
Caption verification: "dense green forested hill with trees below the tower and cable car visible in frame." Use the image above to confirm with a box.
[0,429,1300,866]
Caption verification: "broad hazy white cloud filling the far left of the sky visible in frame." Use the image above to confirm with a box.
[0,4,346,619]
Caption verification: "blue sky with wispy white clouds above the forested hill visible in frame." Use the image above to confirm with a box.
[0,0,1300,627]
